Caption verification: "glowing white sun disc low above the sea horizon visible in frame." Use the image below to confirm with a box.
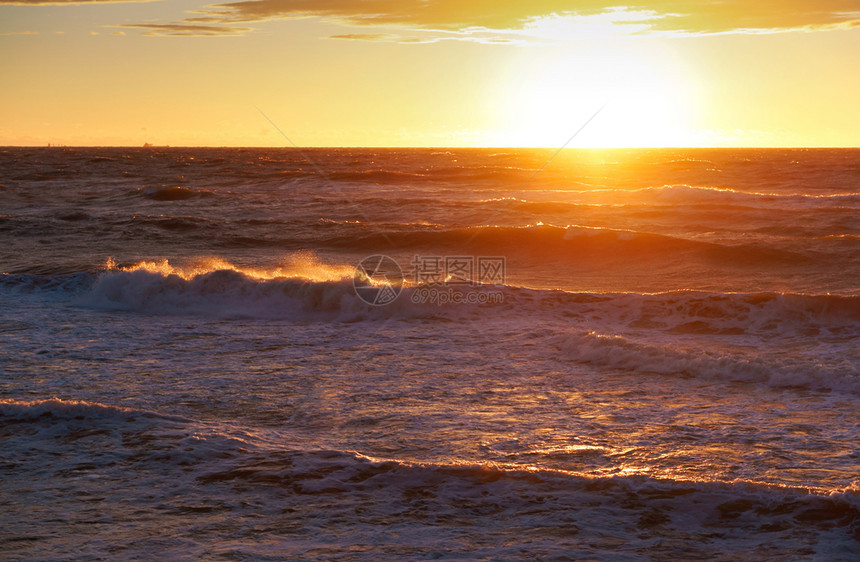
[493,33,696,148]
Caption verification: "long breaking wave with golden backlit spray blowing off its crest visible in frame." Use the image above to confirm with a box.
[0,256,860,330]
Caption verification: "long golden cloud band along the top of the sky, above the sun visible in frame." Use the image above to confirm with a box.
[53,0,860,39]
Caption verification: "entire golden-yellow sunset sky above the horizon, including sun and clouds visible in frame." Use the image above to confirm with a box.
[0,0,860,147]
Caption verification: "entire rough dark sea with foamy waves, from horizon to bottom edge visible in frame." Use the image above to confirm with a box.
[0,148,860,560]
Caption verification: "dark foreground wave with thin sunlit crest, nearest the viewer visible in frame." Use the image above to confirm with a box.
[0,400,860,559]
